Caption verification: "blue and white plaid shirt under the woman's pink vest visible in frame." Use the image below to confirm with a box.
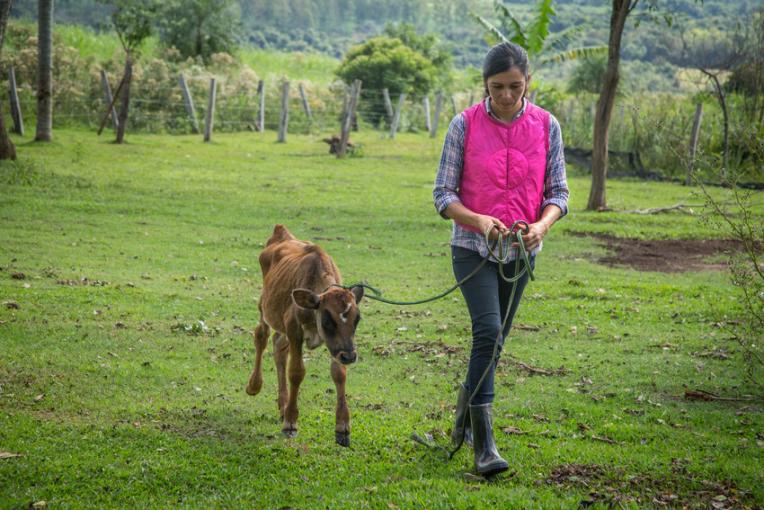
[432,98,570,261]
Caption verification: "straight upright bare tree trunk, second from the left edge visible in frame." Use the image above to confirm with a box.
[35,0,53,142]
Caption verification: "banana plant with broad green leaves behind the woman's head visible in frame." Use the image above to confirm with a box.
[470,0,607,67]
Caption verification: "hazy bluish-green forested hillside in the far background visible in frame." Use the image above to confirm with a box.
[11,0,764,86]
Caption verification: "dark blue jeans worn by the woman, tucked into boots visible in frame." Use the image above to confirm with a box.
[451,246,535,405]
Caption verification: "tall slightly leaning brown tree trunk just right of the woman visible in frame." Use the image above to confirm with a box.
[586,0,639,211]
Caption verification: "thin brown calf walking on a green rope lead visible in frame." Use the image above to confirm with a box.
[247,225,363,446]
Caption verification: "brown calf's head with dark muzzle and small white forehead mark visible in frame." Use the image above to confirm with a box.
[292,286,363,365]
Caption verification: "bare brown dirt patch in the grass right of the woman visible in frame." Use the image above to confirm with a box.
[575,232,742,273]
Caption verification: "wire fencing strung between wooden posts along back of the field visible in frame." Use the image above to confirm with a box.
[0,66,760,183]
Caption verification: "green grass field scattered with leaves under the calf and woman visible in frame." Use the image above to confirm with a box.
[0,126,764,509]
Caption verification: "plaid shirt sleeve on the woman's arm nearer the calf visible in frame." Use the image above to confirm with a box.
[432,114,464,219]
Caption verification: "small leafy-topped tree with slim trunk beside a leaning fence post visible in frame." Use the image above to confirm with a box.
[100,0,157,143]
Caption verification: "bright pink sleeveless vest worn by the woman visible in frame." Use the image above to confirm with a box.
[459,101,549,234]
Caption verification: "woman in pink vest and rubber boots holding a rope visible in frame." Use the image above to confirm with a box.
[433,43,569,476]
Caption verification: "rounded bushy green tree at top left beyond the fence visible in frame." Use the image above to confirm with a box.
[160,0,241,60]
